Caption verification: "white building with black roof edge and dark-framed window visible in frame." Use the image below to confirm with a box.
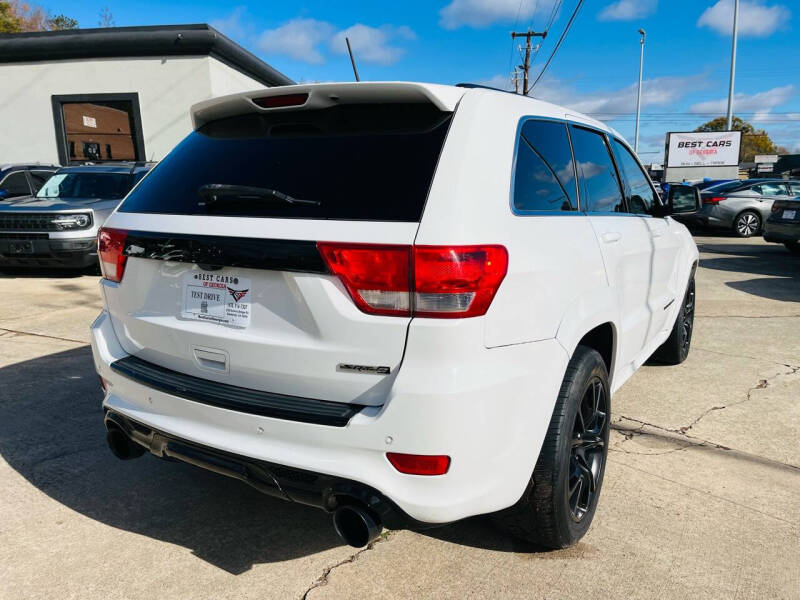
[0,25,293,165]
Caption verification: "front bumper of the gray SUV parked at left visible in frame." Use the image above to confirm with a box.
[0,234,98,269]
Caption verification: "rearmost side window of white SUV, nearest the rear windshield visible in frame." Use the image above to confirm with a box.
[514,120,578,212]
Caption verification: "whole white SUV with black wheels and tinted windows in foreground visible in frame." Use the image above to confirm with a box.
[92,83,699,548]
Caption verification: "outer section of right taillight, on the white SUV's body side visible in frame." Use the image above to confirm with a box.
[414,246,508,318]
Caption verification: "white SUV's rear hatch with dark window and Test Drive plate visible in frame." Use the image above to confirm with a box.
[101,84,462,405]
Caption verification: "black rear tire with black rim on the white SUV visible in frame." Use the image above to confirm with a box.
[493,346,611,549]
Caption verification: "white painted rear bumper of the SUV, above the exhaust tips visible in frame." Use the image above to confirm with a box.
[92,312,568,524]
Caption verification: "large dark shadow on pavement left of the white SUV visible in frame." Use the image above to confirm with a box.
[0,347,341,574]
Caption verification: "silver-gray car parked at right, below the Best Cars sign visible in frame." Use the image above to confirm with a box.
[679,179,800,237]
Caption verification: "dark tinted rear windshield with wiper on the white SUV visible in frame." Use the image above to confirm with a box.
[119,104,451,222]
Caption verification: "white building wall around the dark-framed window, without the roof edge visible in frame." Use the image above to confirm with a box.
[0,56,264,164]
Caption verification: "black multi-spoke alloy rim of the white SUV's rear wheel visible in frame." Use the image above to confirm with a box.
[567,377,608,523]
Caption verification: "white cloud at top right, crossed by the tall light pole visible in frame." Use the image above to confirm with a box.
[697,0,791,37]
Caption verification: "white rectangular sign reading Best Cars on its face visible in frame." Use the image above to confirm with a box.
[667,131,742,167]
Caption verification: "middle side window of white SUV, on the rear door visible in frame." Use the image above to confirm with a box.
[572,126,625,212]
